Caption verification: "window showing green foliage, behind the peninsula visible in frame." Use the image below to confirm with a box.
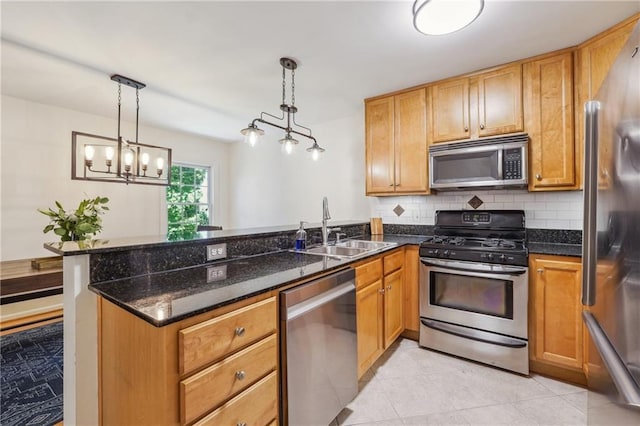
[167,163,211,240]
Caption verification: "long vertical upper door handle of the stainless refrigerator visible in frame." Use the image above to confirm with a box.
[582,101,600,306]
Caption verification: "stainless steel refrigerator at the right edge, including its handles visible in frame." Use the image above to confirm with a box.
[582,19,640,425]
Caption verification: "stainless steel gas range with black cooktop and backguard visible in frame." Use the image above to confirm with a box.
[419,210,529,374]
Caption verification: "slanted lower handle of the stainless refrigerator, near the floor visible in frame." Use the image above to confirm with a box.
[582,311,640,407]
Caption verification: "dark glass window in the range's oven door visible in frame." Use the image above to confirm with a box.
[429,271,513,319]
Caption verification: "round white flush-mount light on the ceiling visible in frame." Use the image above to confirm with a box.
[413,0,484,35]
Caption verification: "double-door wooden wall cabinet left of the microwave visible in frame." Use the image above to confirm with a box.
[365,88,429,195]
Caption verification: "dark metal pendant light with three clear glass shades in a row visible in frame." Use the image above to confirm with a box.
[240,58,324,160]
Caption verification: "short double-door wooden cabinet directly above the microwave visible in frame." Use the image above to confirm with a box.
[427,64,523,143]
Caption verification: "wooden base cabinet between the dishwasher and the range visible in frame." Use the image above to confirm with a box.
[356,248,404,377]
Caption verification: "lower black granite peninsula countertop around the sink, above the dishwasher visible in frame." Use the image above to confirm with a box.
[89,235,425,327]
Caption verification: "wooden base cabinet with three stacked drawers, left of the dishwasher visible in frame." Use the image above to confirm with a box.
[99,294,279,425]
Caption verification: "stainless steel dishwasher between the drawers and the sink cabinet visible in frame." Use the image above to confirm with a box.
[280,269,358,426]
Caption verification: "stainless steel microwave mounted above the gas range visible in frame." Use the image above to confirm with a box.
[429,133,529,191]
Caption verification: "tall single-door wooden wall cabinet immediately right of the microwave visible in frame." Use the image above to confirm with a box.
[523,52,577,191]
